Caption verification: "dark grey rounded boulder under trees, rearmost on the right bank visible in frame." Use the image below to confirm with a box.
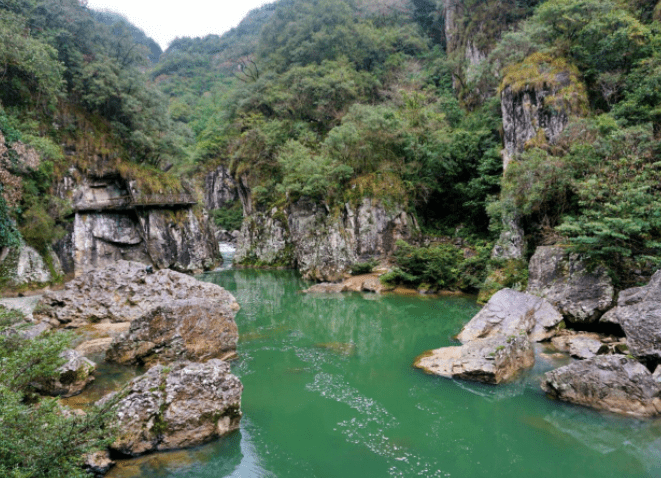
[527,246,614,323]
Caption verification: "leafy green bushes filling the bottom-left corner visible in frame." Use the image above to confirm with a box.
[0,310,113,478]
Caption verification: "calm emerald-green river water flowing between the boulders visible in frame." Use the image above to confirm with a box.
[111,270,661,478]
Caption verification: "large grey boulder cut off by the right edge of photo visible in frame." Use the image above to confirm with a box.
[600,270,661,364]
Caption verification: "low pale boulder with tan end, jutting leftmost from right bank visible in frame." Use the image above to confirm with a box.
[414,335,535,384]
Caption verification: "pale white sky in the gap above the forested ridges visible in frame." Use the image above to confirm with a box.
[87,0,273,50]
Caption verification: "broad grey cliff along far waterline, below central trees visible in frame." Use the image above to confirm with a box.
[235,198,416,281]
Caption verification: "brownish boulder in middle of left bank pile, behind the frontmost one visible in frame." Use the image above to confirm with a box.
[106,299,239,366]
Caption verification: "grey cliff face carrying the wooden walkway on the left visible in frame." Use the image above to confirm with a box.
[55,173,219,275]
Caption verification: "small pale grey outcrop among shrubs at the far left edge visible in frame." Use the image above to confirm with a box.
[0,241,63,287]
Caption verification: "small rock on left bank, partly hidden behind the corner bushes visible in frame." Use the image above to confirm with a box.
[35,349,96,398]
